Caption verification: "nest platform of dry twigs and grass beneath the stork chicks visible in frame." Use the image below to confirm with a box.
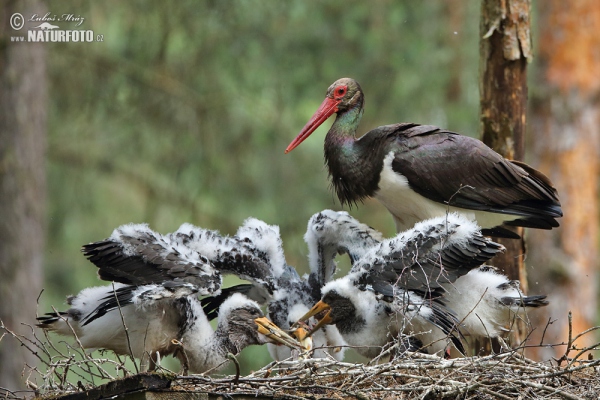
[172,350,600,399]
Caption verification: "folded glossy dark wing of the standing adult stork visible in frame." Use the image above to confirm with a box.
[386,124,562,229]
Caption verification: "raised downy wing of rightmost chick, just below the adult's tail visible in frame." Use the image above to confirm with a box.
[352,214,504,296]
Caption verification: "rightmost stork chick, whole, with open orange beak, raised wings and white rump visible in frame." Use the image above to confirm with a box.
[301,210,548,357]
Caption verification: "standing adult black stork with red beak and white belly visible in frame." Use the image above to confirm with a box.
[285,78,562,238]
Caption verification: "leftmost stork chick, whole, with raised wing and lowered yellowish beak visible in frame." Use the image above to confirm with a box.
[38,224,301,373]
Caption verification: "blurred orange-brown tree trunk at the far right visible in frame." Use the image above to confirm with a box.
[528,0,600,359]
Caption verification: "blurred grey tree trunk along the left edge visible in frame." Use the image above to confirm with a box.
[0,1,47,390]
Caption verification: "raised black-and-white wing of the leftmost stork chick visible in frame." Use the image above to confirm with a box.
[82,224,273,295]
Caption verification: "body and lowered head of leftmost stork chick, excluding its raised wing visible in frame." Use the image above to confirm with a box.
[37,290,300,373]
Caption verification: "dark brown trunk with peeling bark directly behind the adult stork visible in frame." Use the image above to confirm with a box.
[479,0,531,350]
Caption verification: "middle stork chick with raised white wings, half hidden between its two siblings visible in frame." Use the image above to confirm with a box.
[196,213,346,361]
